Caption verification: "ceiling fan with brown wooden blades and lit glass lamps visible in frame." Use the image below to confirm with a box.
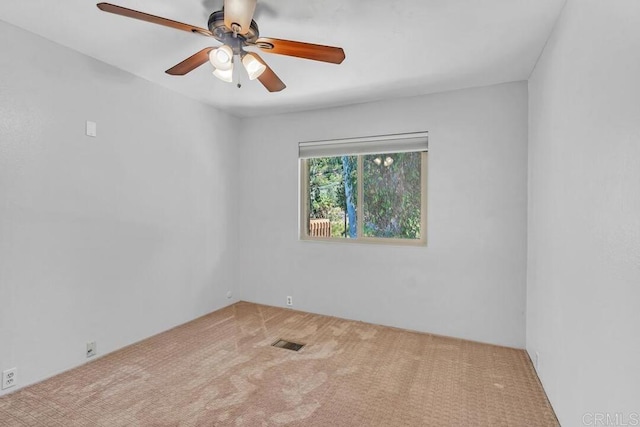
[97,0,345,92]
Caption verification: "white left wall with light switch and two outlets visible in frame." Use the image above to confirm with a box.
[0,21,238,394]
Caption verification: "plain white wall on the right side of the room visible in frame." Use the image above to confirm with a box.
[527,0,640,426]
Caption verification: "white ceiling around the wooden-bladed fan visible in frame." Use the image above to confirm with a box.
[0,0,565,116]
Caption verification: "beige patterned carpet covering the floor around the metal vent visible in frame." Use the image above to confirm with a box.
[0,302,558,427]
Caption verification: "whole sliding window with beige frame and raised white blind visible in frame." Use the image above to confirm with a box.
[299,132,428,245]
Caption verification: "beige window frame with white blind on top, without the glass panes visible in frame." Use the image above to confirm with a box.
[298,132,429,246]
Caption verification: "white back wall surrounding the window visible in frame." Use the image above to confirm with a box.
[238,82,527,348]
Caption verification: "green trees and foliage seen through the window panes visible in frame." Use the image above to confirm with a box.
[304,152,426,240]
